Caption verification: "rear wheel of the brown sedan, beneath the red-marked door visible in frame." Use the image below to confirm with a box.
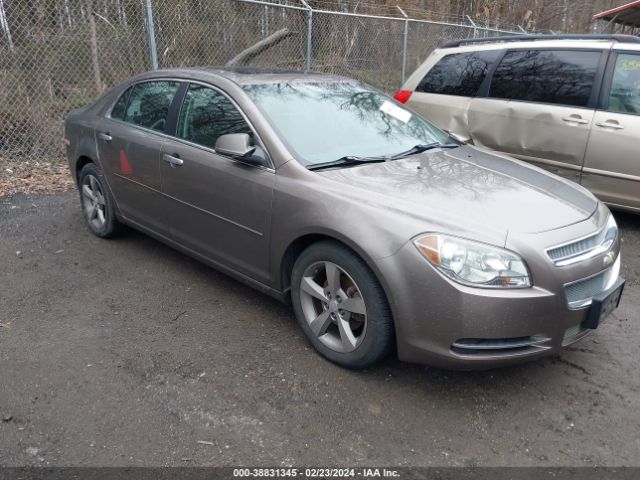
[78,163,122,238]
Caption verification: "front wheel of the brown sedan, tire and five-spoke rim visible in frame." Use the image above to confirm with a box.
[291,241,394,369]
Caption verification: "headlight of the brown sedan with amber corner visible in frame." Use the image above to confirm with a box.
[413,233,531,288]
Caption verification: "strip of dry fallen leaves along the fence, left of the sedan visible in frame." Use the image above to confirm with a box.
[0,157,75,197]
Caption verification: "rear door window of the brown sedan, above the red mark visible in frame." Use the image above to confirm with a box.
[124,81,180,132]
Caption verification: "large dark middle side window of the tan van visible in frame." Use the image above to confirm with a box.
[489,50,600,107]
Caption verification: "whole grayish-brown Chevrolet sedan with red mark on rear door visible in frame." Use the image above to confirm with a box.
[65,69,624,369]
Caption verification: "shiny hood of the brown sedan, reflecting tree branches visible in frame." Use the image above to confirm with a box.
[317,145,598,234]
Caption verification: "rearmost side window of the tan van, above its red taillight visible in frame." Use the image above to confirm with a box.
[416,51,498,97]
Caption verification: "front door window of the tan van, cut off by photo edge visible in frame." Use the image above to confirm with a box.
[607,53,640,115]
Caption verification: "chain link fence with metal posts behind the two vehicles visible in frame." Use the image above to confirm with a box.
[0,0,528,161]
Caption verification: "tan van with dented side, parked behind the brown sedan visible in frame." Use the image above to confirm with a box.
[396,35,640,213]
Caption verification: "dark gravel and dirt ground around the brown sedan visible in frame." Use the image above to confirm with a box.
[0,192,640,466]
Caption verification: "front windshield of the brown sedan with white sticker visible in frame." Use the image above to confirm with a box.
[244,81,451,166]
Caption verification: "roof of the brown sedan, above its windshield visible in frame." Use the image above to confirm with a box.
[130,66,356,86]
